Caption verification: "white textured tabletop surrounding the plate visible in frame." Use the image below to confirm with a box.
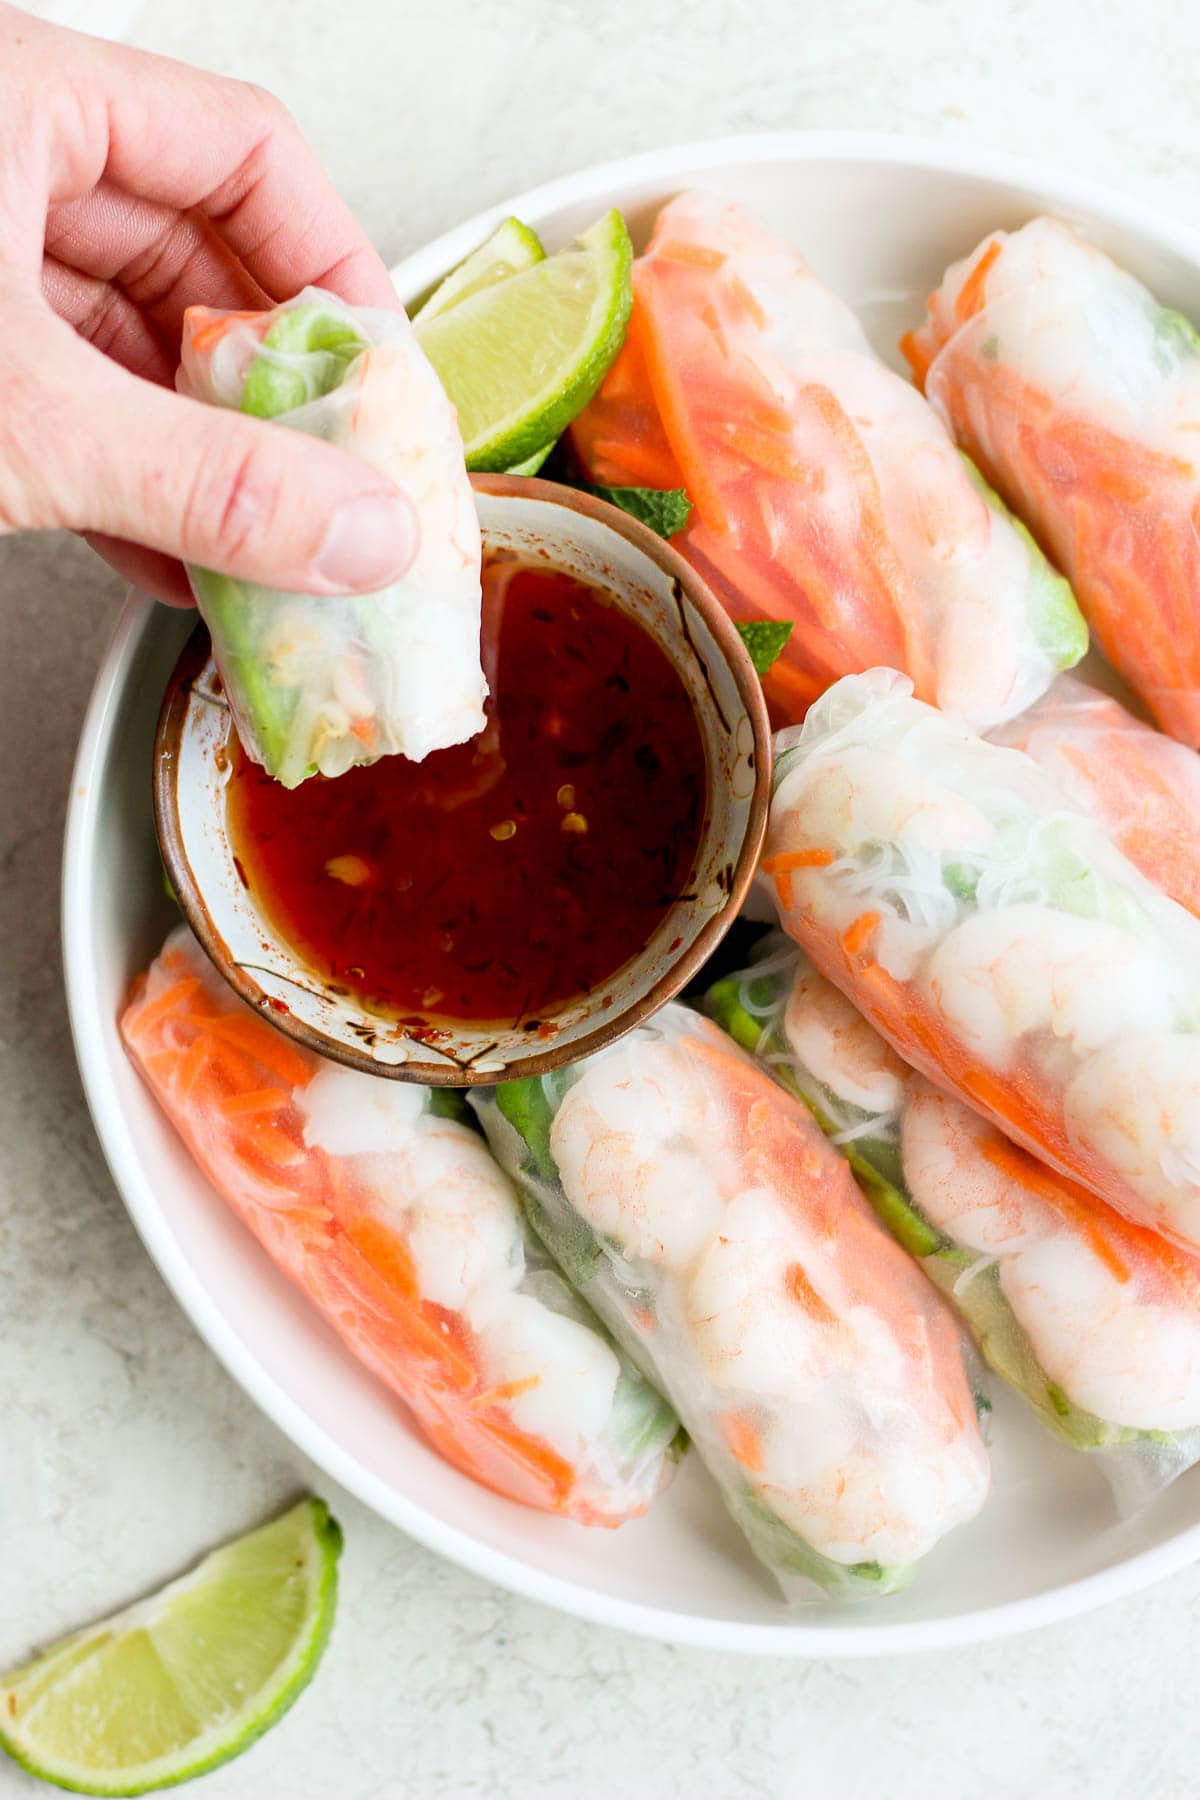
[0,0,1200,1800]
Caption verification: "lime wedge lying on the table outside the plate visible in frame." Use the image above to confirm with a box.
[0,1499,342,1795]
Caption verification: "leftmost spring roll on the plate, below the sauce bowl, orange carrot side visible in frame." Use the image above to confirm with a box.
[121,927,678,1525]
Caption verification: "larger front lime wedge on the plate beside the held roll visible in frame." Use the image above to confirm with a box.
[417,211,633,470]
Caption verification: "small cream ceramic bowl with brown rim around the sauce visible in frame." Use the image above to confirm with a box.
[155,475,770,1087]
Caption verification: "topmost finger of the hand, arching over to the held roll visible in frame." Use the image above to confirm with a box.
[49,32,399,308]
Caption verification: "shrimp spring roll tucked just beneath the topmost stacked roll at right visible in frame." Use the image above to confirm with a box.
[709,940,1200,1512]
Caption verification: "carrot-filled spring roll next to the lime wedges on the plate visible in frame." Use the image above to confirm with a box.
[572,193,1087,731]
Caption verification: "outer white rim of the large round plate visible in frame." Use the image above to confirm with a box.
[61,130,1200,1660]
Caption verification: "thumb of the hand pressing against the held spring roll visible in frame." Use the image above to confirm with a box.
[0,315,419,594]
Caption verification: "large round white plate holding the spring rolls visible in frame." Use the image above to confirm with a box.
[63,133,1200,1656]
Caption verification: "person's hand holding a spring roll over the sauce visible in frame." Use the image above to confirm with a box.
[0,4,417,601]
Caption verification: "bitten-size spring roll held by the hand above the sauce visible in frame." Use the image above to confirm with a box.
[180,288,488,787]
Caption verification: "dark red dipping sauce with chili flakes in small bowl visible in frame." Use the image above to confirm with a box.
[228,554,707,1031]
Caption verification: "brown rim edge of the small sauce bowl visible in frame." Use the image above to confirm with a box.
[153,475,772,1087]
